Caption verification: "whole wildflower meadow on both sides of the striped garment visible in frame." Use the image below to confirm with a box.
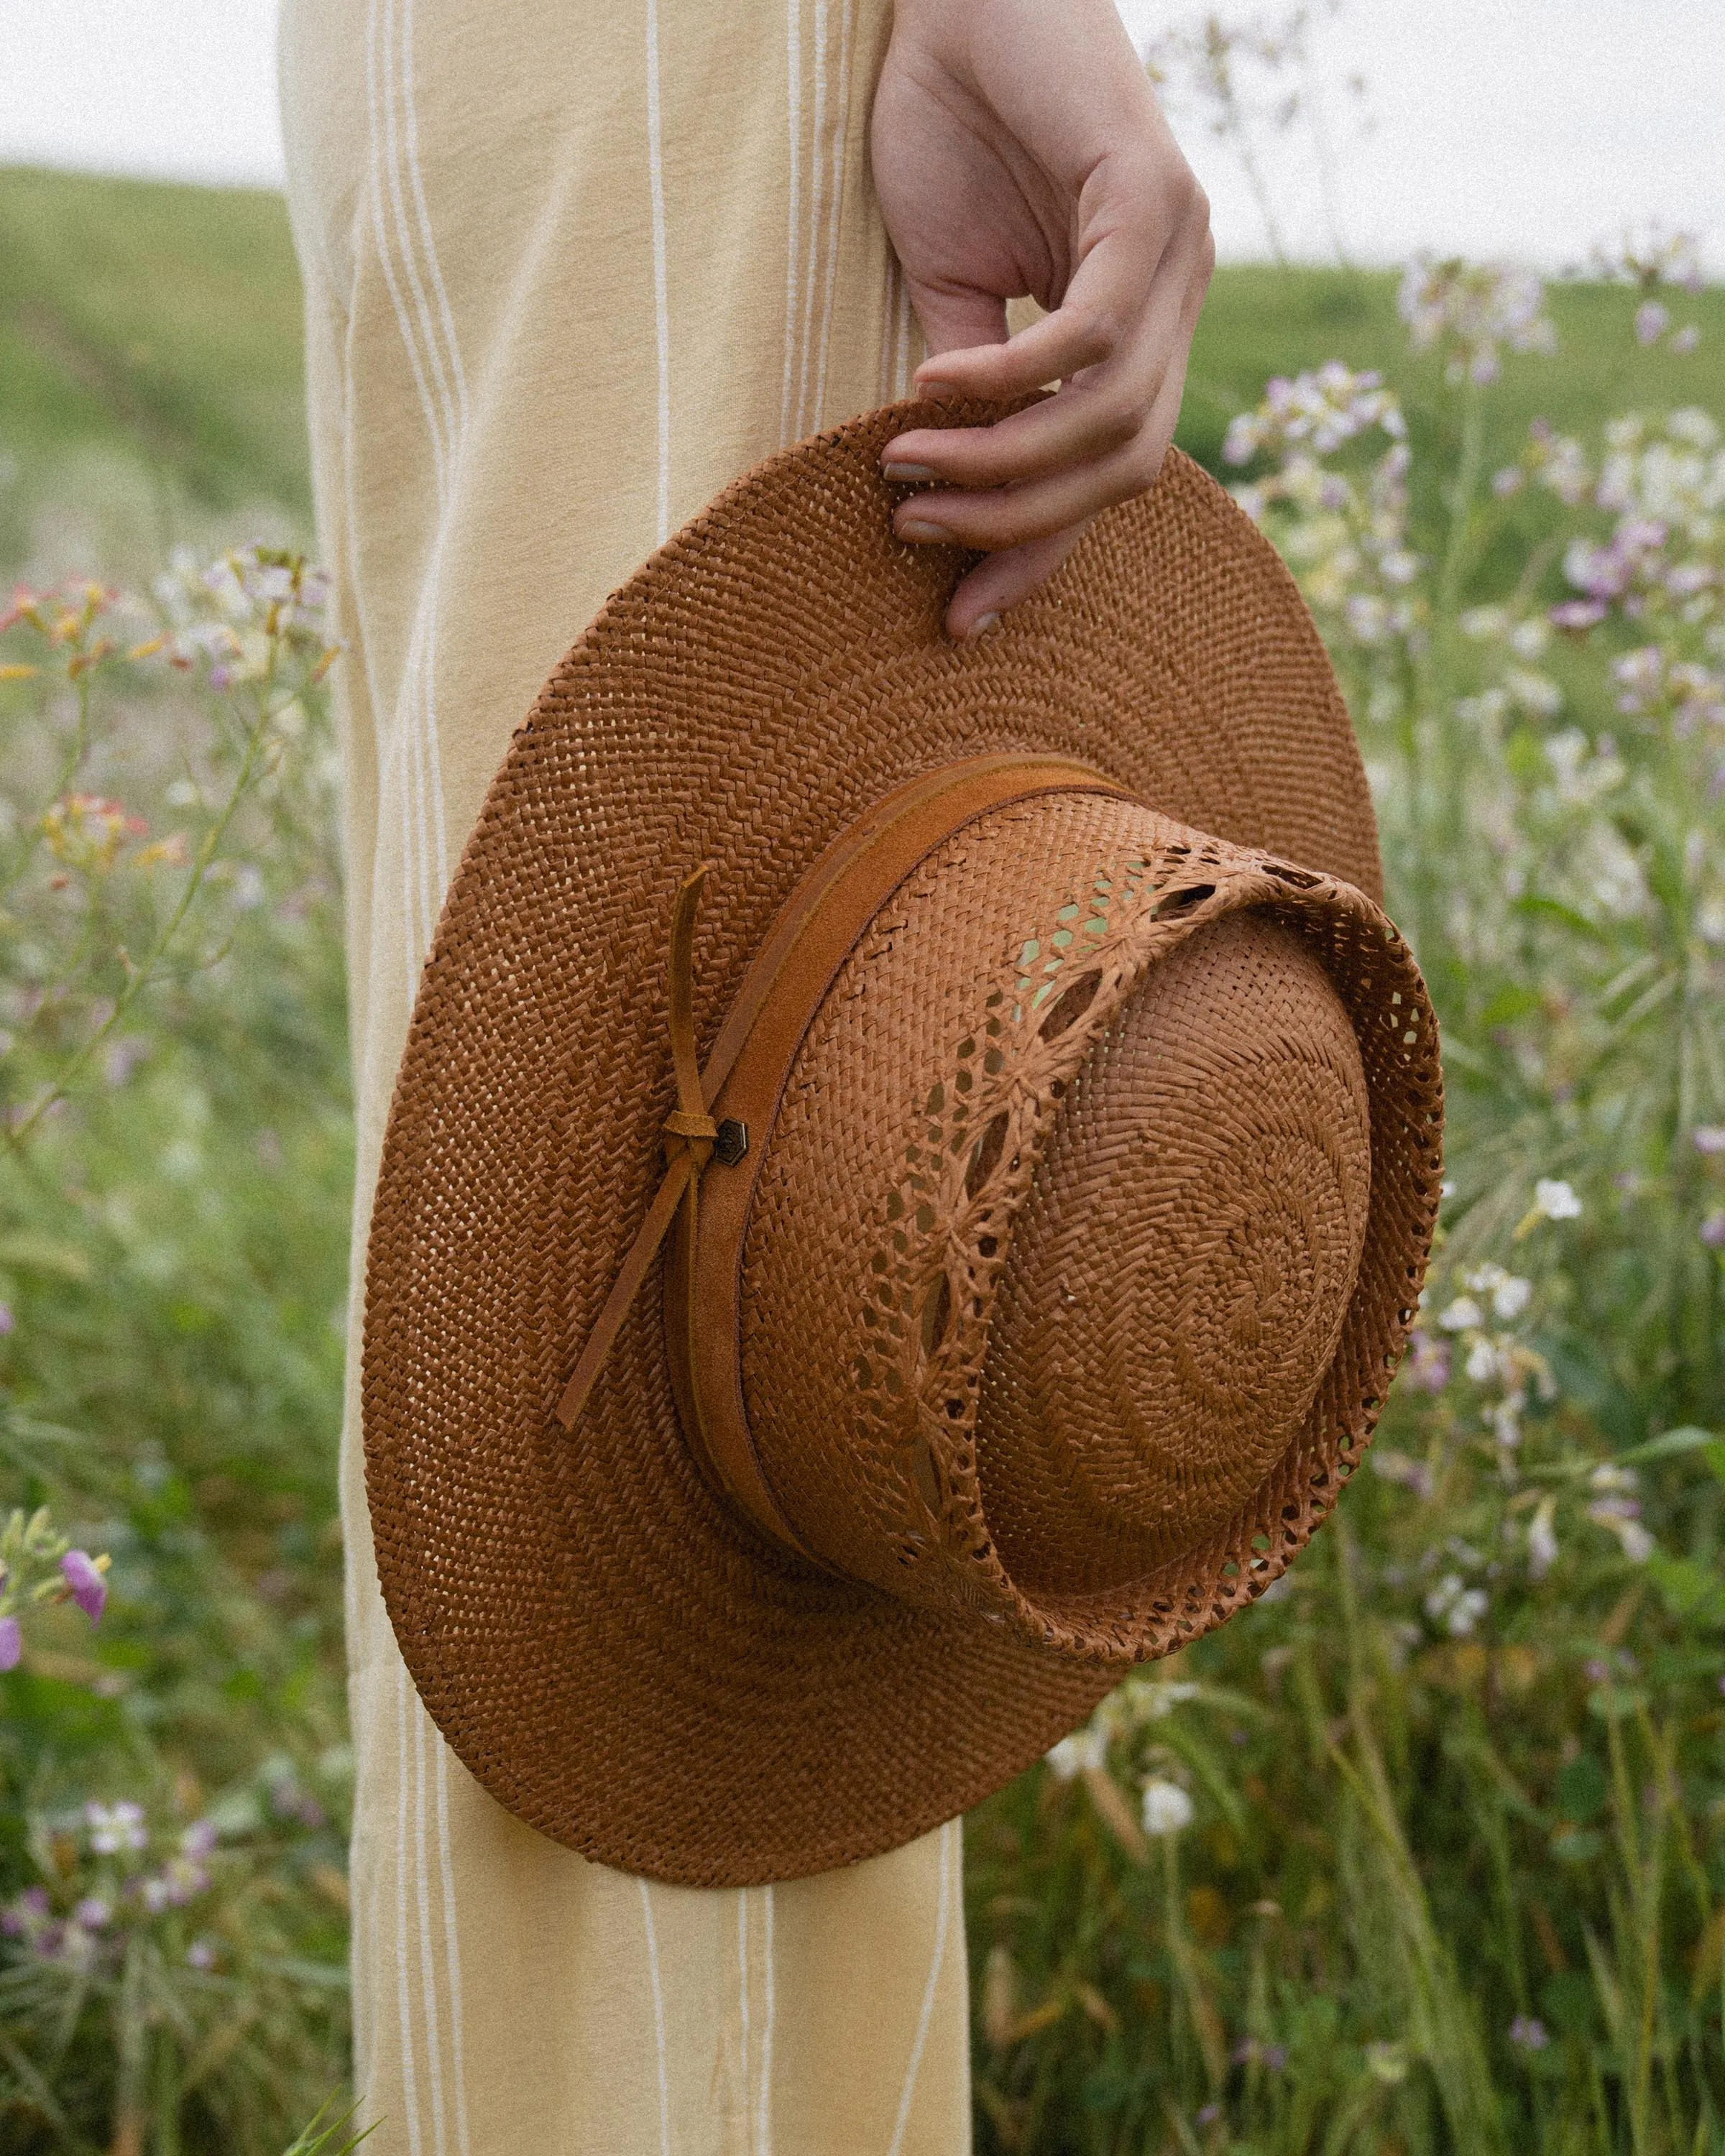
[0,164,1725,2156]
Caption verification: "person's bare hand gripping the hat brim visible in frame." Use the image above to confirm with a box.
[871,0,1216,638]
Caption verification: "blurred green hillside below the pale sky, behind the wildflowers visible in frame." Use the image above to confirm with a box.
[0,170,1725,567]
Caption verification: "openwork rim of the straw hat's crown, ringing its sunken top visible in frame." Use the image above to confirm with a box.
[854,826,1443,1660]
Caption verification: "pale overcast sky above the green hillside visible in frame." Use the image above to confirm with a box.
[0,0,1725,276]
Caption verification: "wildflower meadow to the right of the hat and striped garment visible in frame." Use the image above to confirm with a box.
[968,233,1725,2156]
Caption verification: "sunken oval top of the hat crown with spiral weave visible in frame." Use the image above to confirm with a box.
[977,914,1371,1593]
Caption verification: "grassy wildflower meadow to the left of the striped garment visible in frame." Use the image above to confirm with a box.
[0,535,349,2156]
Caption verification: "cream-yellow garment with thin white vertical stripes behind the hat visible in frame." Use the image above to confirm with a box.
[280,0,970,2156]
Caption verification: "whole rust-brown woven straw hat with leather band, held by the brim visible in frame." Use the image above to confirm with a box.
[364,407,1440,1884]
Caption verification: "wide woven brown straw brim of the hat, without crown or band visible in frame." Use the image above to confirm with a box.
[362,405,1380,1886]
